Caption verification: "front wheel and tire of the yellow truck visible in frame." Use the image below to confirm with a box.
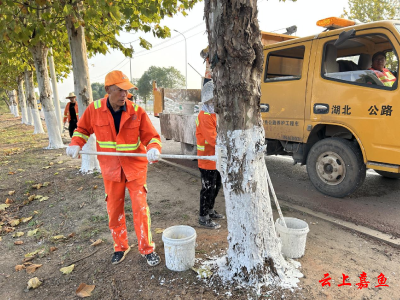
[307,138,366,198]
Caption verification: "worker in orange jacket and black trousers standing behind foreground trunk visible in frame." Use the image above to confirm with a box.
[196,81,225,229]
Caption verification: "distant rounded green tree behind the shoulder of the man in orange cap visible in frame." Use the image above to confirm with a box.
[137,66,185,100]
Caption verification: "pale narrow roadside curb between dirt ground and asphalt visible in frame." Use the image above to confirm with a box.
[161,159,400,248]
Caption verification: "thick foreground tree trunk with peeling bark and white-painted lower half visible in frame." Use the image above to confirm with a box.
[204,0,298,288]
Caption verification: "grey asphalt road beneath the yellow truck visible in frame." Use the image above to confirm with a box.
[151,116,400,238]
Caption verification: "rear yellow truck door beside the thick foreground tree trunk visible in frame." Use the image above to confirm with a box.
[261,41,311,142]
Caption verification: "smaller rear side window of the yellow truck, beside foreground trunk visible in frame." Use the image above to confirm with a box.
[264,46,305,82]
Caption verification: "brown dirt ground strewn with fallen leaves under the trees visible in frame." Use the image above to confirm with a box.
[0,114,400,299]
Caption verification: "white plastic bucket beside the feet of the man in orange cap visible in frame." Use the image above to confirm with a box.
[162,225,196,271]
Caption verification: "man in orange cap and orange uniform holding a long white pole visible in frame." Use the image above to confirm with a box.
[67,71,161,266]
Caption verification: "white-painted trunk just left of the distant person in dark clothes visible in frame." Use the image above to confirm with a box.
[29,42,64,149]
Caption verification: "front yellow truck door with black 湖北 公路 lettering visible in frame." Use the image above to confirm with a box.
[310,27,400,167]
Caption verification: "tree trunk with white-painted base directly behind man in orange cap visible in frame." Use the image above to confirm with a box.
[65,16,100,173]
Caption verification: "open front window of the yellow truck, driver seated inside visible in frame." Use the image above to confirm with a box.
[321,34,398,89]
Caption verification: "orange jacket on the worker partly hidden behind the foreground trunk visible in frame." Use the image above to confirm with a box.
[196,111,217,170]
